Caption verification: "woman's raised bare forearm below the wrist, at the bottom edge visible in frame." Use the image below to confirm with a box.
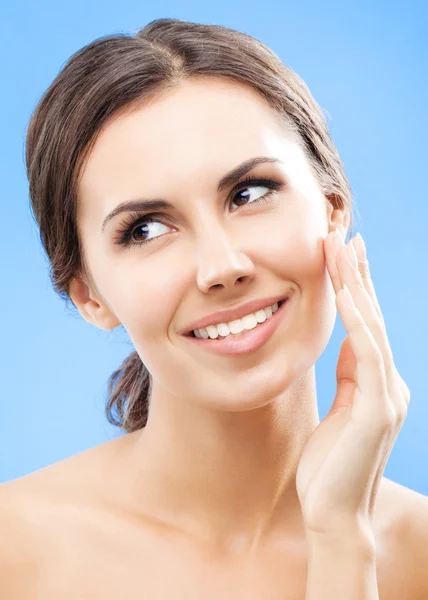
[305,536,379,600]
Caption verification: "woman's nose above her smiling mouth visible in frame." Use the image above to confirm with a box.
[197,228,255,293]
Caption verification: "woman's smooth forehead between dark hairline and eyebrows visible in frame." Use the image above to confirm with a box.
[80,77,304,216]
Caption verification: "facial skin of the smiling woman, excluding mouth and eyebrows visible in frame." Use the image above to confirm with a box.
[73,78,345,411]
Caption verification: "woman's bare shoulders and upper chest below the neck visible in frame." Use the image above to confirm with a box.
[0,434,428,600]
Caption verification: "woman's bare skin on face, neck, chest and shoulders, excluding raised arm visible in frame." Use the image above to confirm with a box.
[0,79,426,600]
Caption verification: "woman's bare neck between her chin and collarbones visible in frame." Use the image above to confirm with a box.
[118,367,319,553]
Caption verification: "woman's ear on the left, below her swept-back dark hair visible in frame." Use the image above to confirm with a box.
[69,277,121,330]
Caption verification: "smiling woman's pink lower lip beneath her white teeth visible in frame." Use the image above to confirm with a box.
[184,298,290,355]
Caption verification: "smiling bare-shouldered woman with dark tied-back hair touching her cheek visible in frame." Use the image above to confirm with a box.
[0,19,428,600]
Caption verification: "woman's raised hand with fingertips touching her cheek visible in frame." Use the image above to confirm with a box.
[296,230,410,541]
